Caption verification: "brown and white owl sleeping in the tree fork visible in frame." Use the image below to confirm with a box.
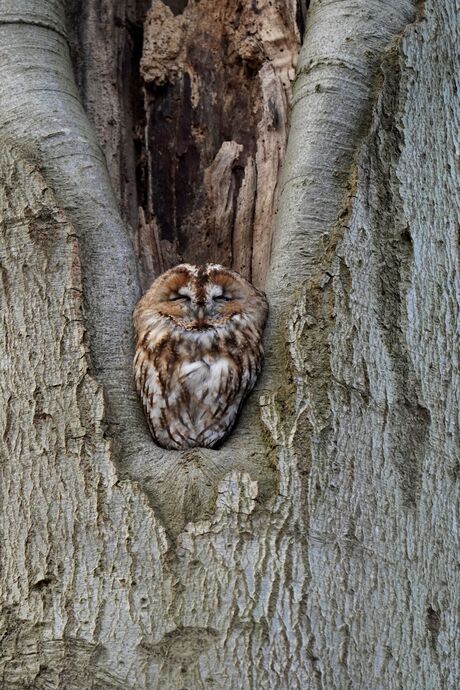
[134,264,268,450]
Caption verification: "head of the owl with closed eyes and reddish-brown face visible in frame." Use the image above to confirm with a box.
[135,264,268,331]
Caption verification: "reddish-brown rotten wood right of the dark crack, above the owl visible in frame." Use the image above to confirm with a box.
[141,0,299,286]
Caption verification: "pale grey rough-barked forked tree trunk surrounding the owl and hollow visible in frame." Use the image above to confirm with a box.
[0,0,460,690]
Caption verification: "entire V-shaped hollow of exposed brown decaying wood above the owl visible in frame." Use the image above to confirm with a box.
[67,0,305,287]
